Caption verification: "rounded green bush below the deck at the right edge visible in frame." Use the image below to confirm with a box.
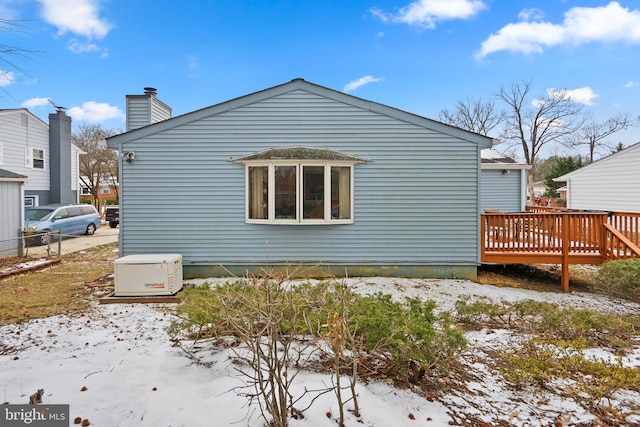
[595,258,640,301]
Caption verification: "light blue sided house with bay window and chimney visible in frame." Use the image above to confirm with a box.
[107,79,492,279]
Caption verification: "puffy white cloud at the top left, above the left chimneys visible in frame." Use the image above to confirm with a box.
[38,0,111,39]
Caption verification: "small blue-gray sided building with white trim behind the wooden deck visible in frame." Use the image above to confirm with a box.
[481,148,531,212]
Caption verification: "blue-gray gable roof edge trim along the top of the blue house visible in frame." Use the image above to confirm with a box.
[107,79,493,148]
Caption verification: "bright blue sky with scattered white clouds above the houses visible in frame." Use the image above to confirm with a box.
[0,0,640,159]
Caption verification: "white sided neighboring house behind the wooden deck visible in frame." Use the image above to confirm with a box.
[554,143,640,212]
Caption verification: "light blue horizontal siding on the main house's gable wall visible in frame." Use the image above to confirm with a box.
[120,90,479,265]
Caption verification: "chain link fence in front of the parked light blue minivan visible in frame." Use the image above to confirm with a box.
[0,231,63,259]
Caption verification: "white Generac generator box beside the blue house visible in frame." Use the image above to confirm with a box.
[114,254,182,296]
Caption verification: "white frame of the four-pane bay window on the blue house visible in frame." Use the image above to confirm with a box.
[245,160,355,225]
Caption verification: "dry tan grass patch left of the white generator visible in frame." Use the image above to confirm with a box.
[0,243,118,325]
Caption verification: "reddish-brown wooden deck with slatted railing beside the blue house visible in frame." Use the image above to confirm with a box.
[480,207,640,292]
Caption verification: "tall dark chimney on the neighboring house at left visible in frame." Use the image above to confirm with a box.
[49,108,77,203]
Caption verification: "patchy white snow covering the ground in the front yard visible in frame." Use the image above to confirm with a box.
[0,278,640,427]
